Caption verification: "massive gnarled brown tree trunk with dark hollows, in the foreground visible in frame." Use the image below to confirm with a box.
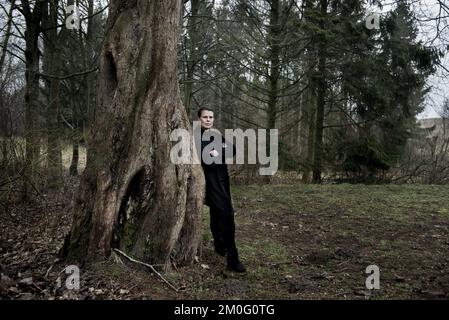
[63,0,204,269]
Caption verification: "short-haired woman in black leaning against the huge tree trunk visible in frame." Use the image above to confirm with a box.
[198,107,246,272]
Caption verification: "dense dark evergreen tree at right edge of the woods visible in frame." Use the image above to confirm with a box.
[339,1,438,180]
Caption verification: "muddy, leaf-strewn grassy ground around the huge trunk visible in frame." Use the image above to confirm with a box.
[0,180,449,300]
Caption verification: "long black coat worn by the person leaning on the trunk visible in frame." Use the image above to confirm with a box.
[201,130,236,212]
